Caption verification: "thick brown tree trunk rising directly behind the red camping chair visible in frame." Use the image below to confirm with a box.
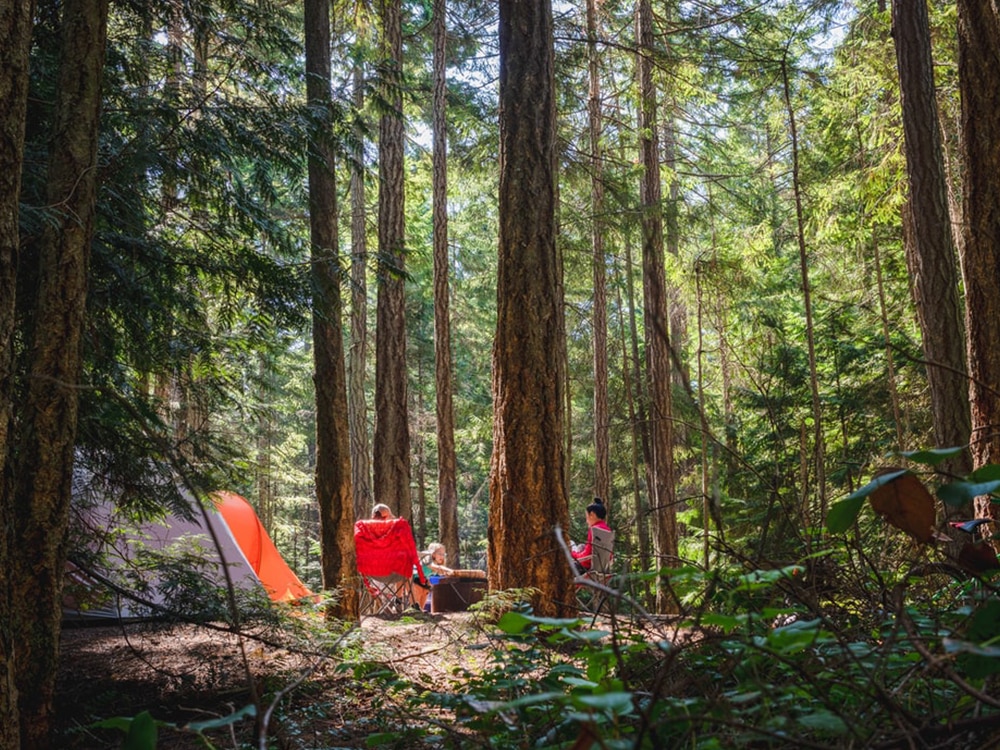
[374,0,413,520]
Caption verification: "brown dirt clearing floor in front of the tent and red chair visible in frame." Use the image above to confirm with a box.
[57,613,485,750]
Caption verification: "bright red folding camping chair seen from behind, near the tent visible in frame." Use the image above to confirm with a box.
[354,518,427,615]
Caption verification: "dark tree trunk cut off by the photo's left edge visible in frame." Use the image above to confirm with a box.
[0,0,34,750]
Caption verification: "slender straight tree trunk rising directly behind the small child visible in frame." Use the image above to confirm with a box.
[434,0,461,567]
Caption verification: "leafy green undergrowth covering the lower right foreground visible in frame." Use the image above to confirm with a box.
[304,550,1000,748]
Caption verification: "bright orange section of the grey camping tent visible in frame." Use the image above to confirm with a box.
[213,491,313,602]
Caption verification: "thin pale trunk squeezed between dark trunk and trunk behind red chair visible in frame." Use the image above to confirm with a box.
[347,63,373,518]
